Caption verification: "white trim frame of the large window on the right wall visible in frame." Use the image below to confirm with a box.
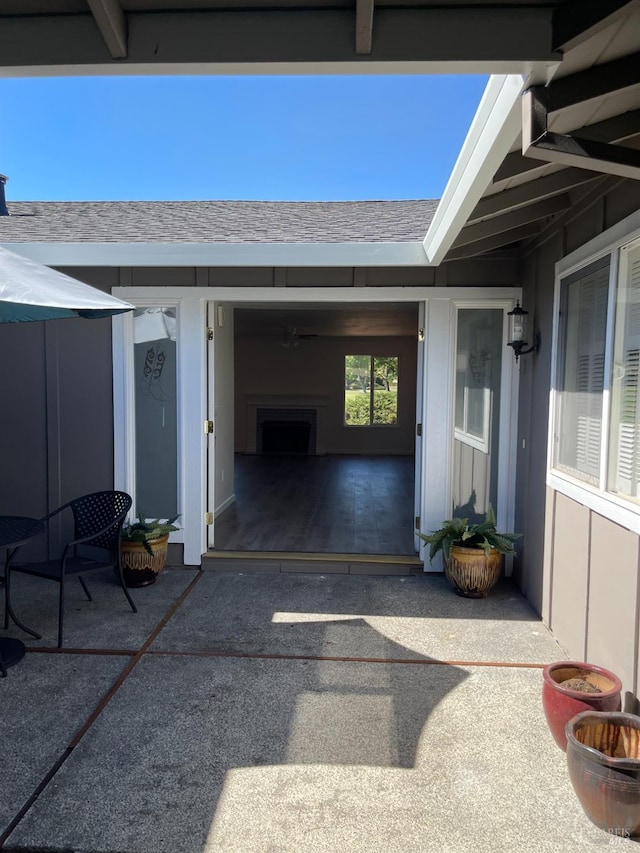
[547,211,640,534]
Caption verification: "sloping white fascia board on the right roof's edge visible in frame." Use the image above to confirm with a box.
[423,74,524,266]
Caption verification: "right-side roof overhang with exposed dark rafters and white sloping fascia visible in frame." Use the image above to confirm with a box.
[424,2,640,265]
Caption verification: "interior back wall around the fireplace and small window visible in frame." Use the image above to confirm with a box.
[235,337,417,455]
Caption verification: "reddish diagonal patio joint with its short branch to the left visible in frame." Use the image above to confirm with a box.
[0,571,204,850]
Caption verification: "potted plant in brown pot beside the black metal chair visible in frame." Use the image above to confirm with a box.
[120,514,179,587]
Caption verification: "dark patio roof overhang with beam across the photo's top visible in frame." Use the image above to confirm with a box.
[0,0,564,74]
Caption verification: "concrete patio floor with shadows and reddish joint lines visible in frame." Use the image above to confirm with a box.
[0,569,638,853]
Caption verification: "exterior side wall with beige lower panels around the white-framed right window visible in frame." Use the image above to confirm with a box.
[514,179,640,705]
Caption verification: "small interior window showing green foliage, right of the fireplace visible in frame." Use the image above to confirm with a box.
[344,355,398,426]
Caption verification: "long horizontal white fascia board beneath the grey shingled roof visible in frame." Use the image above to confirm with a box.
[0,241,429,267]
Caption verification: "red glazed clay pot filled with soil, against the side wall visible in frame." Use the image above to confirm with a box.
[542,660,622,749]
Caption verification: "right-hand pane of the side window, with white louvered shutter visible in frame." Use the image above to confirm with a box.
[608,243,640,500]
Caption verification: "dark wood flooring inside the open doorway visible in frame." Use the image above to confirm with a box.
[214,455,415,556]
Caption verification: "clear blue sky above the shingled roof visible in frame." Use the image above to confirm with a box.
[0,76,487,201]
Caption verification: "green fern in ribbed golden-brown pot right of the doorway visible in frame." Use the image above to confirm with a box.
[418,504,521,598]
